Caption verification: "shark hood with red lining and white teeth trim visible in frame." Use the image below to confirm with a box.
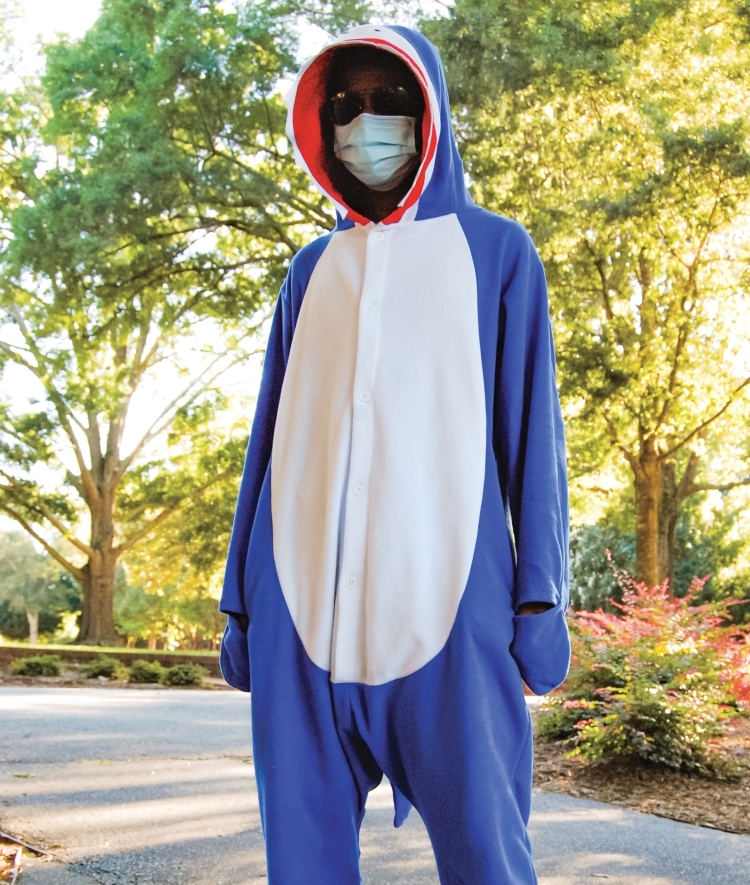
[287,25,473,229]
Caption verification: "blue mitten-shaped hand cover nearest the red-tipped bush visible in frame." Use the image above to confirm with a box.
[510,603,570,694]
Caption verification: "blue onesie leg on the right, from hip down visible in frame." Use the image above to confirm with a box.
[359,568,537,885]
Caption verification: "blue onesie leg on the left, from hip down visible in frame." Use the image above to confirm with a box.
[250,564,382,885]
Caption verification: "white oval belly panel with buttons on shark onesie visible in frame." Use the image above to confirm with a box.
[272,215,486,685]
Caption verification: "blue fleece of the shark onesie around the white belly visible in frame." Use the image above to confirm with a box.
[220,28,570,885]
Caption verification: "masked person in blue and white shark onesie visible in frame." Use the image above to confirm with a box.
[220,25,570,885]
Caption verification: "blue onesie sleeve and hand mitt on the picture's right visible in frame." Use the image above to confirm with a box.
[493,235,570,694]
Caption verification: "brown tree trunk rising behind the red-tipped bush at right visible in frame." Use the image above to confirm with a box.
[634,438,664,587]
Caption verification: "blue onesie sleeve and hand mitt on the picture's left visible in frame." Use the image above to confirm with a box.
[219,283,291,691]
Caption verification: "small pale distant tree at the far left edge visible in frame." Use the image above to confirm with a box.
[0,532,68,645]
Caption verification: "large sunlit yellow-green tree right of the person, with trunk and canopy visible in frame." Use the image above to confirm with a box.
[424,0,750,586]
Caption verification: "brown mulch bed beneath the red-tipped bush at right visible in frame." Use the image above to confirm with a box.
[534,719,750,834]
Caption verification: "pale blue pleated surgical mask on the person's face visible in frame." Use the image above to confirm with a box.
[333,114,419,191]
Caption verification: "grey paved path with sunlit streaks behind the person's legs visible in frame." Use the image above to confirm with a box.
[0,688,750,885]
